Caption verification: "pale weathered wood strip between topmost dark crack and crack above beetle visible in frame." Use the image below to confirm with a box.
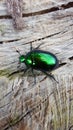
[0,8,73,42]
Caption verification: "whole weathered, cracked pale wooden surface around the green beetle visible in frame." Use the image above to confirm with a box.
[0,0,73,130]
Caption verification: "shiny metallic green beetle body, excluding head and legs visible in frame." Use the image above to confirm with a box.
[25,50,58,71]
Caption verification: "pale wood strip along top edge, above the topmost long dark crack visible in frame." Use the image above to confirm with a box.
[0,0,73,16]
